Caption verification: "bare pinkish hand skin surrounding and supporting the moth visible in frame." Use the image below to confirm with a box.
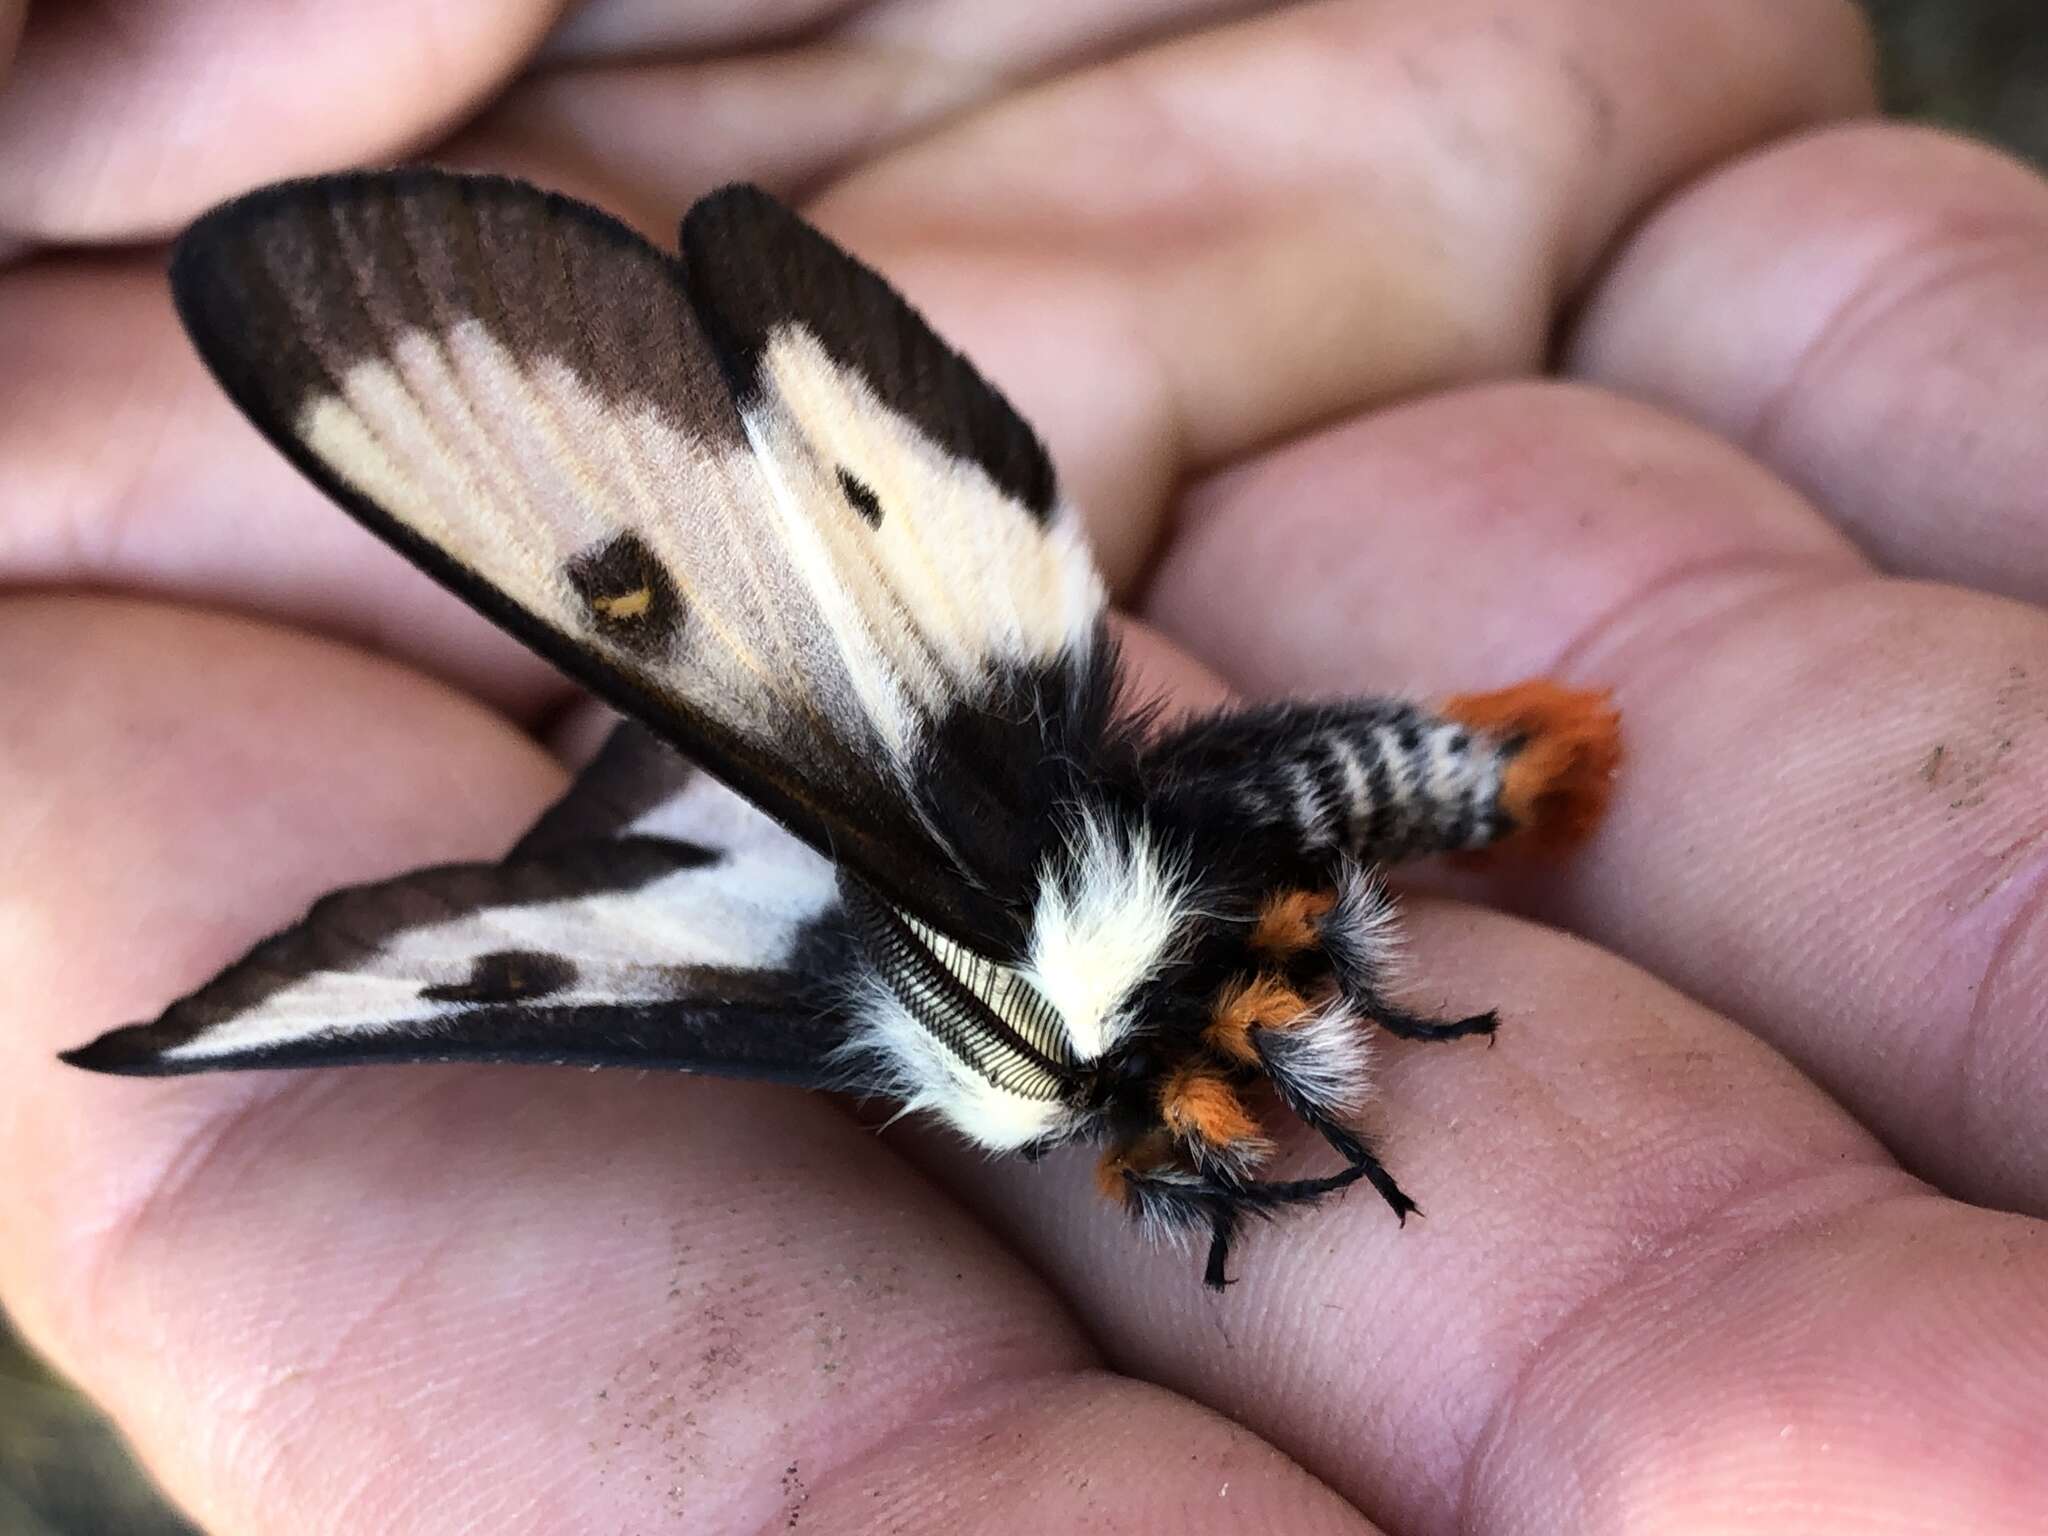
[0,0,2048,1536]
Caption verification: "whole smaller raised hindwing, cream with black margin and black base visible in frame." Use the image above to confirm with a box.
[682,184,1116,954]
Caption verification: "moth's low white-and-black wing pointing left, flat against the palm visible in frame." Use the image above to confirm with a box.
[66,725,858,1087]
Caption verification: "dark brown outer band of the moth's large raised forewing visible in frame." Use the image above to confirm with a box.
[170,168,745,446]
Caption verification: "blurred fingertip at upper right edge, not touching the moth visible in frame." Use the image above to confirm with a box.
[1571,125,2048,602]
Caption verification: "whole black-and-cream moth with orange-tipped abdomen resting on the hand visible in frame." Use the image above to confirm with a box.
[66,170,1618,1286]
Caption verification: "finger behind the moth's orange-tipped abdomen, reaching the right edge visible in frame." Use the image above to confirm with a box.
[1151,385,2048,1210]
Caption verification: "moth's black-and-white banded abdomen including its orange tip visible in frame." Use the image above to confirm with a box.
[1147,682,1620,868]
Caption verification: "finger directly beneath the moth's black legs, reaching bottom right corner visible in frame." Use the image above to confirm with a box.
[928,903,2048,1536]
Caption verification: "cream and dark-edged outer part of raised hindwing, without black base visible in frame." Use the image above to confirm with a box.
[682,184,1102,679]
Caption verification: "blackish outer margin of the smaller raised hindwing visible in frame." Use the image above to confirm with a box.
[682,182,1059,520]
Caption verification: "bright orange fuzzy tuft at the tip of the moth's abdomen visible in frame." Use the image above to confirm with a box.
[1444,680,1622,852]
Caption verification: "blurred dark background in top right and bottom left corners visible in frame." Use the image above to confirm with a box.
[0,0,2048,1536]
